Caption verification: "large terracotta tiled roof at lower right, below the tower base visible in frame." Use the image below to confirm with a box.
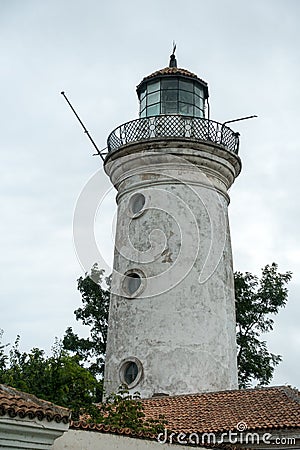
[143,386,300,433]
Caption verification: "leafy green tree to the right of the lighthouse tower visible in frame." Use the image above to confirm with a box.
[234,263,292,388]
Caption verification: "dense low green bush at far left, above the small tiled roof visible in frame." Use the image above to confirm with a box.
[0,336,101,419]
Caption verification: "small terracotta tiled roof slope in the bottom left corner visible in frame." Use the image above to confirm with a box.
[0,384,70,423]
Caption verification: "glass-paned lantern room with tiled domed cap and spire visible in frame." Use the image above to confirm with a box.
[137,53,208,118]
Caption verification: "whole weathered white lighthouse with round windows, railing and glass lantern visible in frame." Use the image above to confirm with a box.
[104,52,241,397]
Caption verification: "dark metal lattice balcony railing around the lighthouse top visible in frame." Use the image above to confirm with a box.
[107,115,239,154]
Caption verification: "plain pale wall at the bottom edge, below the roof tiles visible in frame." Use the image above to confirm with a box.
[52,430,207,450]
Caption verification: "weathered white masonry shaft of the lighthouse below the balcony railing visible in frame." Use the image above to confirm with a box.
[105,141,240,397]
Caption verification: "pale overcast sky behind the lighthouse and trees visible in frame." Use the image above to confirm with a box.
[0,0,300,387]
